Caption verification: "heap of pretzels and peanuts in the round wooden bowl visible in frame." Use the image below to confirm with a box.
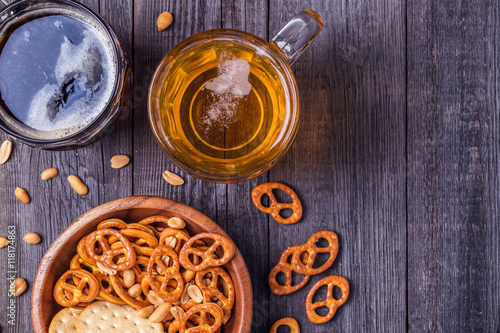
[53,215,235,333]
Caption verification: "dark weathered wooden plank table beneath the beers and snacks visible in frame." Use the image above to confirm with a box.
[0,0,500,333]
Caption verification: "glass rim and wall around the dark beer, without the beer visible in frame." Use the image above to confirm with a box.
[0,0,132,150]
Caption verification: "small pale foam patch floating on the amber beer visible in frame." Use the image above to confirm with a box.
[203,59,252,127]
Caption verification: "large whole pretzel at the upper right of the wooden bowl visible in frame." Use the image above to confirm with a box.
[179,232,235,272]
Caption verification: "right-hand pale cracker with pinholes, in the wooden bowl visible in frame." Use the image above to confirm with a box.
[76,301,163,333]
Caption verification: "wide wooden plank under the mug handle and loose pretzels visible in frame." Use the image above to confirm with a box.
[269,1,406,332]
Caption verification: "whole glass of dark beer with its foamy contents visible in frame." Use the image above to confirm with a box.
[0,0,131,150]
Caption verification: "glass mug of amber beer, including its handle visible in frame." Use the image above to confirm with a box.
[148,10,323,183]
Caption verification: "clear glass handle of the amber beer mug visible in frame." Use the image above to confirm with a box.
[271,9,323,65]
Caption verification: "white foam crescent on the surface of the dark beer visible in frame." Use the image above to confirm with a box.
[26,26,116,137]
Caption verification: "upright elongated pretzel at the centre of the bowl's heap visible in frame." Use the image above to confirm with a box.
[148,245,184,303]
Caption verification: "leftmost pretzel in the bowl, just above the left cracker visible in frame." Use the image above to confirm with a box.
[53,269,99,307]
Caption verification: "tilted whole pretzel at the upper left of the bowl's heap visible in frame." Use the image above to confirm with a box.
[85,229,136,271]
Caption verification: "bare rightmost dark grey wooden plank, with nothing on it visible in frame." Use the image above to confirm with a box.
[408,1,500,332]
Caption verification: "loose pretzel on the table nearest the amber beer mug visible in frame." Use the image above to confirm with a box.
[252,183,302,224]
